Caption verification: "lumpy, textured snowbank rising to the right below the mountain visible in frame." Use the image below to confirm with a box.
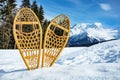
[57,40,120,65]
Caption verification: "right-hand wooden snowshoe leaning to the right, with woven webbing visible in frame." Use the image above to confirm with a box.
[42,14,70,67]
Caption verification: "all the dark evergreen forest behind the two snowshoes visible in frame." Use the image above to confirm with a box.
[0,0,50,49]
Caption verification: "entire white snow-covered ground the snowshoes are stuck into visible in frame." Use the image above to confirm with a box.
[0,40,120,80]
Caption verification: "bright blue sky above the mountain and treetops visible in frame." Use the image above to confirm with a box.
[17,0,120,28]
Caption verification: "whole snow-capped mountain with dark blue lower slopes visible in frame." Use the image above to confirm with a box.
[68,22,118,46]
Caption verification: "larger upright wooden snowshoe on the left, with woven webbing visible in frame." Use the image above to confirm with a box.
[13,8,42,70]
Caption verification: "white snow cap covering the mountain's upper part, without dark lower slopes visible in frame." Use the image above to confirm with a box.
[70,22,118,41]
